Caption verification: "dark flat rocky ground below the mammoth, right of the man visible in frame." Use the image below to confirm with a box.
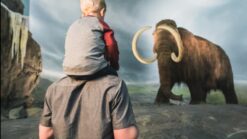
[134,105,247,139]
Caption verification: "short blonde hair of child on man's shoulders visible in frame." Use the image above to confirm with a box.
[80,0,106,13]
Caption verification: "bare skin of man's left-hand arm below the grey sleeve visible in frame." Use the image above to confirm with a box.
[39,124,54,139]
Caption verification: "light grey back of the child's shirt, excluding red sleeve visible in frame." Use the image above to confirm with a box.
[63,16,108,76]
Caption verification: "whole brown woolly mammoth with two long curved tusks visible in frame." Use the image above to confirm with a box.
[132,20,238,104]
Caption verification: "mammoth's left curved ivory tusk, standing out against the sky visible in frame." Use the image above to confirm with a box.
[132,26,157,64]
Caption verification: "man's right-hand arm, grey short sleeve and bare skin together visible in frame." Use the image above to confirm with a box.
[111,81,138,139]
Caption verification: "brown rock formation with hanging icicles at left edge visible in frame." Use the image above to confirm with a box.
[1,0,42,116]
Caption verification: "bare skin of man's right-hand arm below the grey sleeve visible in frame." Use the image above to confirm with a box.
[114,126,139,139]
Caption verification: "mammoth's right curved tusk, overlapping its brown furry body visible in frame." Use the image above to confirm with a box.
[158,25,184,63]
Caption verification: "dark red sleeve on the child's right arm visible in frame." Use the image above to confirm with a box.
[100,20,119,70]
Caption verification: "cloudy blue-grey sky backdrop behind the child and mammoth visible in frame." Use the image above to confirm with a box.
[30,0,247,83]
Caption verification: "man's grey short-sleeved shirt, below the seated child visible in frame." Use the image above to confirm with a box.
[40,75,136,139]
